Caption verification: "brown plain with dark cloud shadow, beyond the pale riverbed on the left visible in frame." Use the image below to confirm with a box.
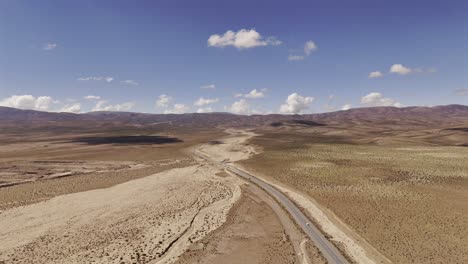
[0,124,223,212]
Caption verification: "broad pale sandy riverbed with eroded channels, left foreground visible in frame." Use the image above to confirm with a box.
[0,165,240,263]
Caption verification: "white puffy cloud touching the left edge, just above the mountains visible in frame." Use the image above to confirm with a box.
[0,94,54,111]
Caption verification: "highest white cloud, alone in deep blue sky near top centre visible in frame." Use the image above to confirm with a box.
[208,29,281,49]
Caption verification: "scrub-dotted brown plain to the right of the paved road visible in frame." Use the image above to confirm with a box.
[241,133,468,263]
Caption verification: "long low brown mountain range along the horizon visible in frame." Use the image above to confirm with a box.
[0,105,468,126]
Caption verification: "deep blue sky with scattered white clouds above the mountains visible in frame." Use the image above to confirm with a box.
[0,0,468,114]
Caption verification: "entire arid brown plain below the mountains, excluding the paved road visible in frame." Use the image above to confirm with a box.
[0,107,468,263]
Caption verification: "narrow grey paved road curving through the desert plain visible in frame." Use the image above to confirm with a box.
[195,150,349,264]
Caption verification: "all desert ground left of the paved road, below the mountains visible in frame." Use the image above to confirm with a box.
[0,122,314,263]
